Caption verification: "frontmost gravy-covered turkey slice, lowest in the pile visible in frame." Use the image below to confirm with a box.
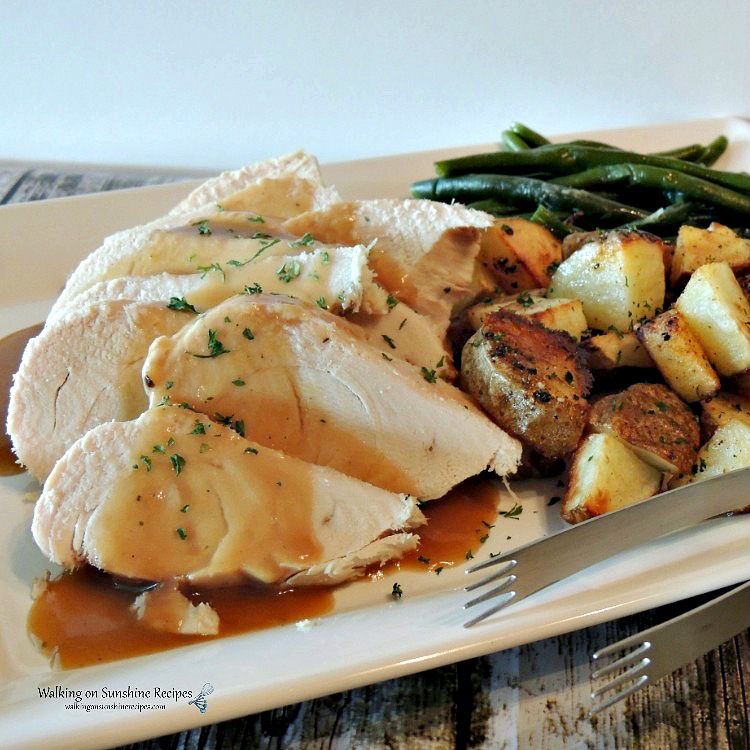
[32,406,425,585]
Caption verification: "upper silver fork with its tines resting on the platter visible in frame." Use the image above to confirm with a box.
[464,468,750,628]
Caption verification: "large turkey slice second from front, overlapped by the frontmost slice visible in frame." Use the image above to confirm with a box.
[143,295,521,499]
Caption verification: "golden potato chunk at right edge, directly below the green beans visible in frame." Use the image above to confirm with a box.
[670,222,750,285]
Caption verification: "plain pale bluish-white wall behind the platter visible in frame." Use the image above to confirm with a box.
[0,0,750,169]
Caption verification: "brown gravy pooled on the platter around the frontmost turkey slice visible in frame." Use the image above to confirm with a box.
[28,478,498,669]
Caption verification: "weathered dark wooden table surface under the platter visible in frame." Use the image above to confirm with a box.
[0,166,750,750]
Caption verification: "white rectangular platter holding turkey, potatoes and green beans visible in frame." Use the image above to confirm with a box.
[0,119,750,750]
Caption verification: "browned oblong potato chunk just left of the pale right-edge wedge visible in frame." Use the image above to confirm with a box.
[636,308,721,402]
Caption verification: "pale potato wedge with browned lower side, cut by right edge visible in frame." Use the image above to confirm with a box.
[675,263,750,376]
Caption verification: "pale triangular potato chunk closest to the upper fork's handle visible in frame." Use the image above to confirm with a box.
[560,433,662,523]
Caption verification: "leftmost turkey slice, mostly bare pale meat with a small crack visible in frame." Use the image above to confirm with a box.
[7,299,191,482]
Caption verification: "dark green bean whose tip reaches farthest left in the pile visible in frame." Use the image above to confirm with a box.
[411,174,650,226]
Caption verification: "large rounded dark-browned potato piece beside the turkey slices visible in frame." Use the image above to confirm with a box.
[461,310,591,458]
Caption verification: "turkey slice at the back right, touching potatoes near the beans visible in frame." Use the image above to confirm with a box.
[284,199,493,335]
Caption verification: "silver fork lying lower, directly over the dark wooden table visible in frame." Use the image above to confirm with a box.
[590,581,750,715]
